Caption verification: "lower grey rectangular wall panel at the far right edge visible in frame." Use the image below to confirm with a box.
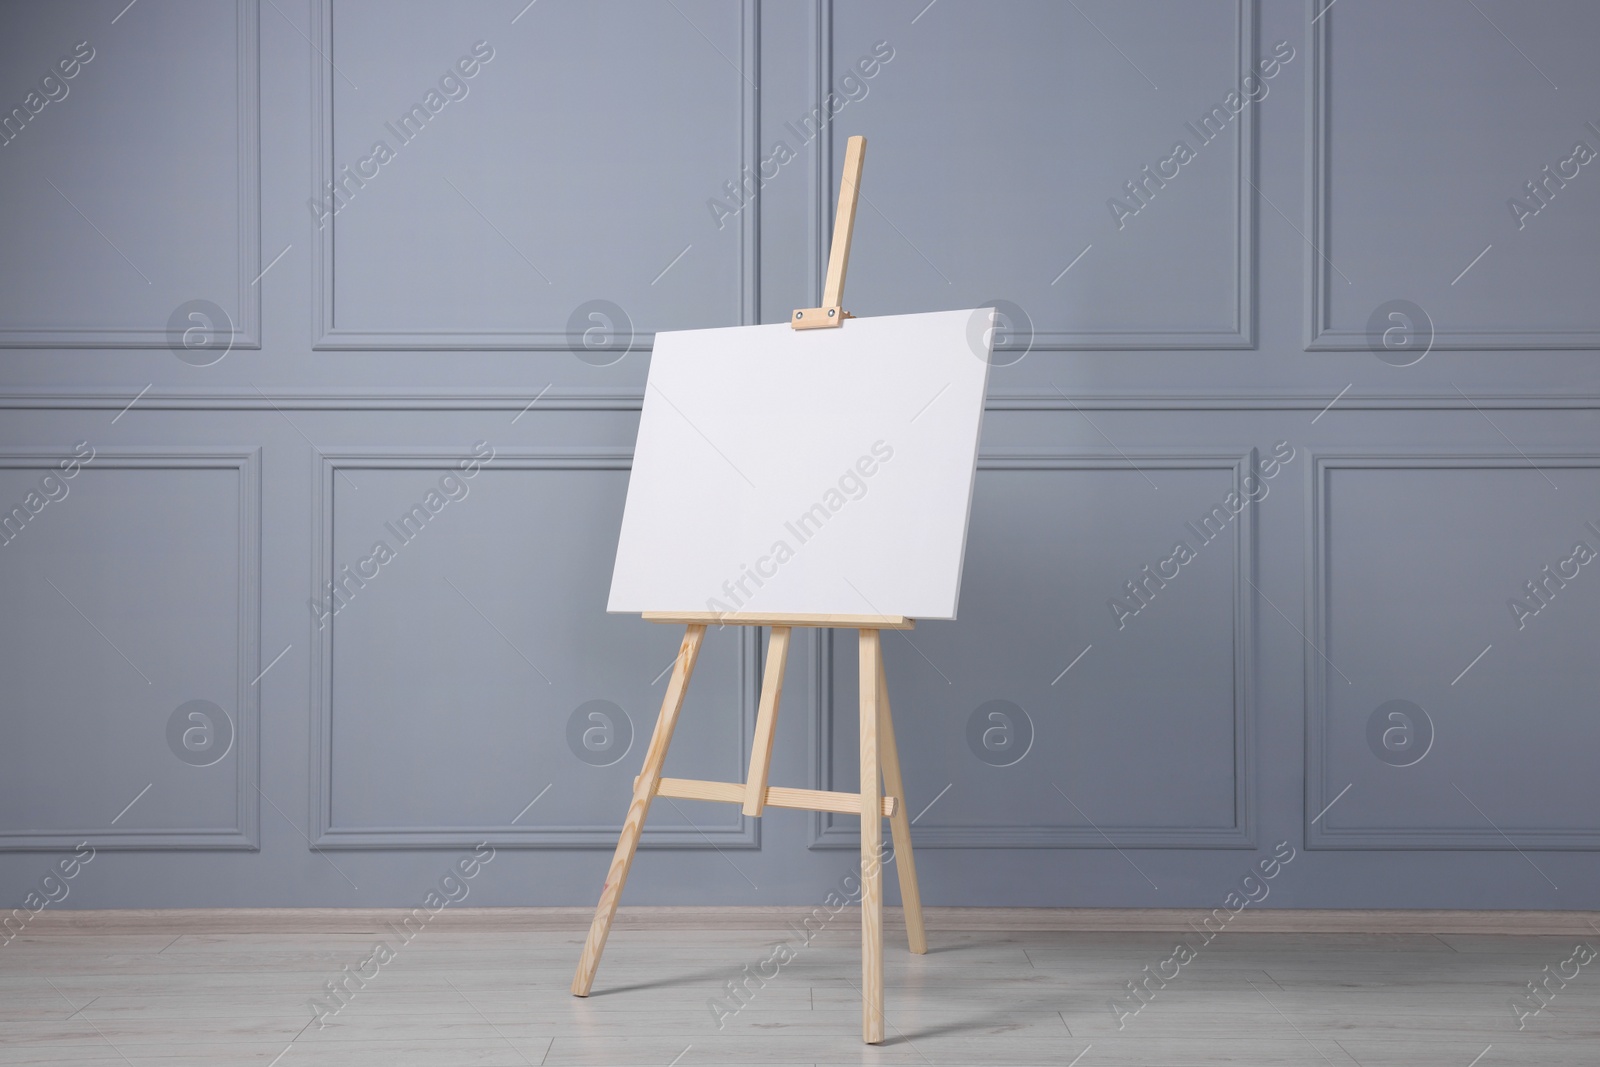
[1306,451,1600,851]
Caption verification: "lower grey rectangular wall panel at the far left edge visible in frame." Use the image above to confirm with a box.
[0,443,261,849]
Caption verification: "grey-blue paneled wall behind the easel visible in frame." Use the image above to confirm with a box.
[0,0,1600,909]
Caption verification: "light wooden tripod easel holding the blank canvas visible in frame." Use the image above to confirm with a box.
[573,138,928,1045]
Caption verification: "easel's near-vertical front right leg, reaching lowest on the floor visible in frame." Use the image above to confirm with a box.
[861,630,883,1045]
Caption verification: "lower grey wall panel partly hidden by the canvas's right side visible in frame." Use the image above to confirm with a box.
[816,450,1248,848]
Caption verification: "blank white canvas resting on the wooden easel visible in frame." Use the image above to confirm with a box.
[608,307,994,619]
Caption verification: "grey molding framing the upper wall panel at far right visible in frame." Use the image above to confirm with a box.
[1304,0,1600,352]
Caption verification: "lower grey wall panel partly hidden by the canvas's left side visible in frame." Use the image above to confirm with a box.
[306,445,758,848]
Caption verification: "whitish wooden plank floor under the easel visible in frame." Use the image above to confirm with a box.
[0,907,1600,1067]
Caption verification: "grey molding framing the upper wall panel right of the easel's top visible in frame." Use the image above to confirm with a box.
[810,0,1259,352]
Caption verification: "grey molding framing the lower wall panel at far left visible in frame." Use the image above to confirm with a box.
[0,446,261,851]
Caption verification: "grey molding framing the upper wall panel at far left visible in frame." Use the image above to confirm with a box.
[0,0,261,350]
